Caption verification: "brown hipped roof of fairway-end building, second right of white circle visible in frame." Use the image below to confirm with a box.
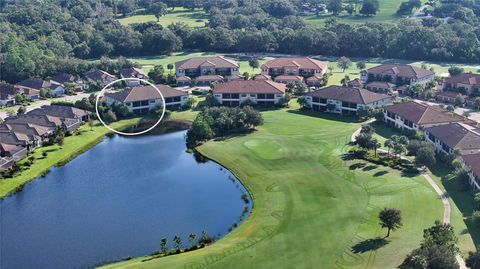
[307,86,391,104]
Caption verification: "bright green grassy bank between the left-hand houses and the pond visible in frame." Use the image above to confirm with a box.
[0,119,139,199]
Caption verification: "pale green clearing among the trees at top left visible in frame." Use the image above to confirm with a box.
[119,8,208,27]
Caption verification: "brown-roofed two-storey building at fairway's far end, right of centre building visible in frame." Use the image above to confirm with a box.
[305,86,393,115]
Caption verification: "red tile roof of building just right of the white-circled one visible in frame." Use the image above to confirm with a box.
[213,80,286,94]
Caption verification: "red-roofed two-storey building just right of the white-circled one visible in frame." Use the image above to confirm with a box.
[213,80,286,106]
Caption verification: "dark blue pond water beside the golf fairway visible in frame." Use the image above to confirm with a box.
[0,132,251,269]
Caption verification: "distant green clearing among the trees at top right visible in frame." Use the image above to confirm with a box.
[304,0,426,25]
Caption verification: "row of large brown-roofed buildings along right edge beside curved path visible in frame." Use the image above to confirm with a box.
[384,101,480,190]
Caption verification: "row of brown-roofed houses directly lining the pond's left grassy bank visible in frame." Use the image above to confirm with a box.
[0,105,89,171]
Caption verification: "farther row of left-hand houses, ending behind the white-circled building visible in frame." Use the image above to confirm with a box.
[0,67,148,107]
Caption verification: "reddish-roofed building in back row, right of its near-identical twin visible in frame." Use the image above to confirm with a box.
[261,57,327,87]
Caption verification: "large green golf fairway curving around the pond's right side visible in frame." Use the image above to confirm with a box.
[102,107,462,269]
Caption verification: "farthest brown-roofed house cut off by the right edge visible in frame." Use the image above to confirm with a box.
[442,73,480,96]
